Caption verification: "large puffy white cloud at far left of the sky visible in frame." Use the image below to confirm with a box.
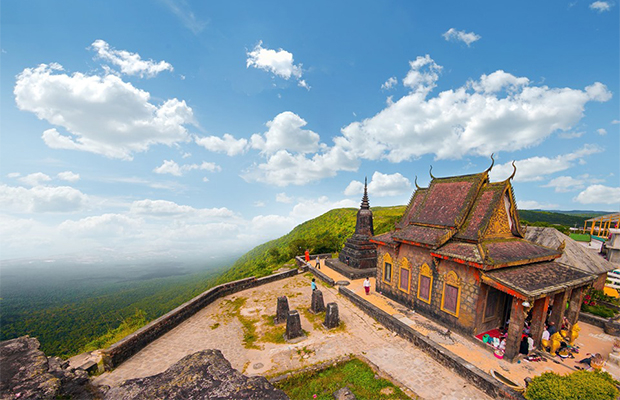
[14,64,194,160]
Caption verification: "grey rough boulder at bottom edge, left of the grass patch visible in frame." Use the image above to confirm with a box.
[105,350,288,400]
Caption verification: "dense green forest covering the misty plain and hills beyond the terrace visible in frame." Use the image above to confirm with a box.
[0,206,600,357]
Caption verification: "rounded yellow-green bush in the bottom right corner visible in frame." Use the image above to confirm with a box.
[525,371,620,400]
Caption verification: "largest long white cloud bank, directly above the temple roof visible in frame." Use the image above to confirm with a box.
[334,56,611,162]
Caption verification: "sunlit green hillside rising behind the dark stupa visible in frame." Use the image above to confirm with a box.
[217,206,405,284]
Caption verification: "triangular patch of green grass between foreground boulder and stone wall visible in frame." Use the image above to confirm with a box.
[275,359,409,400]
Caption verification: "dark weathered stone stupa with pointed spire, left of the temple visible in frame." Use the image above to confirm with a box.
[326,180,377,279]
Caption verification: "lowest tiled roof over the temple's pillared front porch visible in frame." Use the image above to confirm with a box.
[481,262,596,300]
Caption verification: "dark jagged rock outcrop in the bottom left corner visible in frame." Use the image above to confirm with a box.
[0,336,99,400]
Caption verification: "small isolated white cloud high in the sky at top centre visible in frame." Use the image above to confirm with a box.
[246,41,309,89]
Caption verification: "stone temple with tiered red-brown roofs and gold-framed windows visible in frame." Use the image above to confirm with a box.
[371,164,596,361]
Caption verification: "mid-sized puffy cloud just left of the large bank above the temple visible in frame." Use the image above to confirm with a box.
[251,111,320,154]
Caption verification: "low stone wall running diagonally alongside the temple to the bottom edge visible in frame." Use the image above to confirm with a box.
[338,287,524,400]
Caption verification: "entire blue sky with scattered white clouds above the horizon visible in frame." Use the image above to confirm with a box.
[0,0,620,260]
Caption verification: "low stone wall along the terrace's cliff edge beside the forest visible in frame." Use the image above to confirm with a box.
[102,269,300,370]
